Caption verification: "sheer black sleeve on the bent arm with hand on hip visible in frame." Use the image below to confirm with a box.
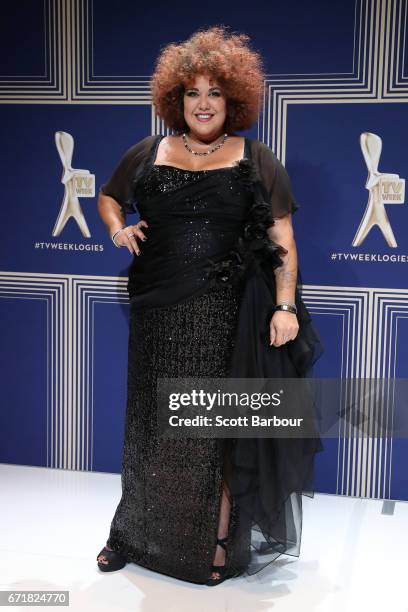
[99,136,155,214]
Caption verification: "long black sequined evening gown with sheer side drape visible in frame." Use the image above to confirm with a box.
[104,137,322,584]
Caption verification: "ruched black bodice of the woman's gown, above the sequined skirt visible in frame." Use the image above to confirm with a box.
[129,145,253,306]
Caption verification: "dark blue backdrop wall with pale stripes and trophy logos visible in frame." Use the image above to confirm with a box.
[0,0,408,500]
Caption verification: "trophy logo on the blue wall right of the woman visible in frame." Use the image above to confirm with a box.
[352,132,405,247]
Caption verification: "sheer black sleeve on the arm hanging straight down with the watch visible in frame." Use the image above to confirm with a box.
[254,141,300,218]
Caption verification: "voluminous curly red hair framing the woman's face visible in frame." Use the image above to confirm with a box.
[152,26,264,134]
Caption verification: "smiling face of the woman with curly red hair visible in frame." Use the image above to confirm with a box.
[183,74,227,142]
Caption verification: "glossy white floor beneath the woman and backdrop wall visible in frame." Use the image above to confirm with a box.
[0,464,408,612]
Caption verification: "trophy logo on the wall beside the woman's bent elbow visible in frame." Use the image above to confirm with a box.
[52,132,95,238]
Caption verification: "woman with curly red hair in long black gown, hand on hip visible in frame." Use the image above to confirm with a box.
[97,26,322,586]
